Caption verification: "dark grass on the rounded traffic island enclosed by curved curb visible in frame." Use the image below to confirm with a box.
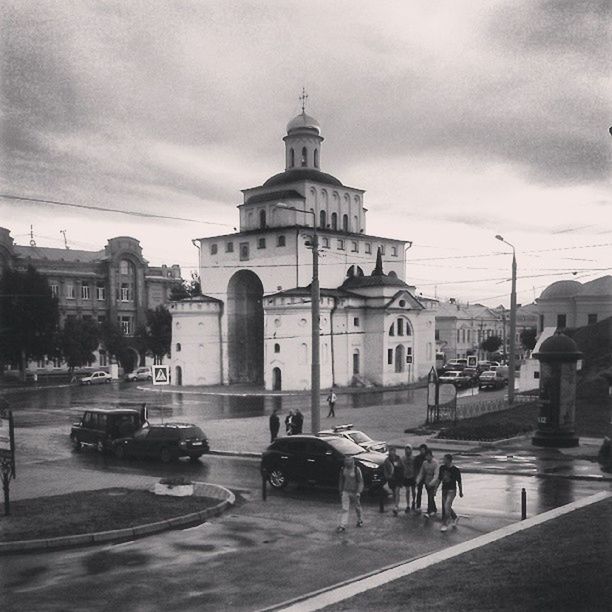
[0,488,219,542]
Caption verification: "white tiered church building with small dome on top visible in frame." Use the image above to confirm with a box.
[170,111,435,389]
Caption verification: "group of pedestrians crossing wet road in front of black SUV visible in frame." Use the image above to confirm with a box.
[338,444,463,531]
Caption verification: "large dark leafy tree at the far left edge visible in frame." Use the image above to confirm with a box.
[0,266,59,380]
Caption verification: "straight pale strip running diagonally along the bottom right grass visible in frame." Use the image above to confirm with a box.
[266,491,612,612]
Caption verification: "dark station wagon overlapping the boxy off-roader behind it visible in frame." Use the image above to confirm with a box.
[113,423,210,463]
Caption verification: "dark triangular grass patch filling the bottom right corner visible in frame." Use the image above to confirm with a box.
[325,499,612,612]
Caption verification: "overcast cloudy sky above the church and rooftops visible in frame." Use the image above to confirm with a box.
[0,0,612,306]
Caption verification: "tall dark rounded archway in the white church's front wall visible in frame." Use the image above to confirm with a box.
[227,270,264,385]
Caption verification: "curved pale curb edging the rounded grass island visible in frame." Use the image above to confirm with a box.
[0,483,236,555]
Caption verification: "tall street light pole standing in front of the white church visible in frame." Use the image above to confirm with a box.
[275,202,321,434]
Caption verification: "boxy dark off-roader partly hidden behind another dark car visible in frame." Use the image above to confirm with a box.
[70,408,145,452]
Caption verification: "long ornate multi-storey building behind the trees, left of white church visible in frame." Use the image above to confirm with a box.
[0,227,181,372]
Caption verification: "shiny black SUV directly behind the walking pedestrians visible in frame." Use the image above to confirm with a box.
[261,435,386,490]
